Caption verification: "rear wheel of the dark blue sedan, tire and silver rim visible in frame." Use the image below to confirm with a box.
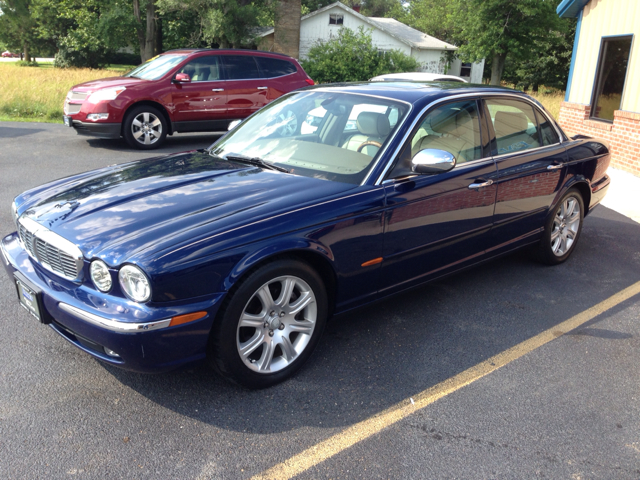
[537,188,584,265]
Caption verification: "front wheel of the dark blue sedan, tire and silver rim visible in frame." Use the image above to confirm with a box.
[208,258,328,389]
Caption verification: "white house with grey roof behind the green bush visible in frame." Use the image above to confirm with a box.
[259,2,484,83]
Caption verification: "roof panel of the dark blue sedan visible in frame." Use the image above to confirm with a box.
[302,80,526,103]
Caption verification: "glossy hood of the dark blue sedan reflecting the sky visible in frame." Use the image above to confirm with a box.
[20,151,355,266]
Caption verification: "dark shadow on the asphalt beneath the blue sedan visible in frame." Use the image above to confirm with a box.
[104,207,640,433]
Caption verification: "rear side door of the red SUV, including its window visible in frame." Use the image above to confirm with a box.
[222,55,269,119]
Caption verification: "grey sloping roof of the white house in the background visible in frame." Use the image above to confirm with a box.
[257,2,458,50]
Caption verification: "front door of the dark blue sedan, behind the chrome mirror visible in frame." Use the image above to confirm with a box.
[381,99,496,292]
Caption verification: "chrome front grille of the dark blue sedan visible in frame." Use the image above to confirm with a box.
[18,217,84,282]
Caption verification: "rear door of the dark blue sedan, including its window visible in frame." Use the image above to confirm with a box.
[484,97,566,249]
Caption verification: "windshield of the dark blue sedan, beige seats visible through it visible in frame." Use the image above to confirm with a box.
[210,91,409,184]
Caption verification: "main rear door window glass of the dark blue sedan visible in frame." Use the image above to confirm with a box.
[486,98,541,155]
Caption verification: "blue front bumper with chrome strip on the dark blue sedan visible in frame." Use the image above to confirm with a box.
[0,233,224,373]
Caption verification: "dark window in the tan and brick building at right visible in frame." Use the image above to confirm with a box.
[591,36,633,122]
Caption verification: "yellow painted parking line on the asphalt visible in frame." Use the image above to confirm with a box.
[252,282,640,480]
